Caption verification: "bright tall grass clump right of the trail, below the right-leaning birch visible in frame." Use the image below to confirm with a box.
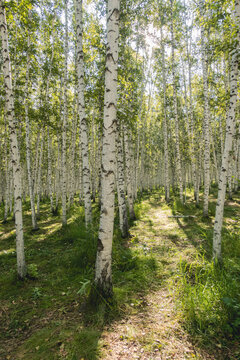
[177,257,240,342]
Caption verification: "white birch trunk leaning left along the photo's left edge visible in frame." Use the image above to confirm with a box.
[0,0,27,279]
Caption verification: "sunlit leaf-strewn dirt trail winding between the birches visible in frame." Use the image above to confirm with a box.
[101,201,215,360]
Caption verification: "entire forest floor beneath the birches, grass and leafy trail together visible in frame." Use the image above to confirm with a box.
[0,192,240,360]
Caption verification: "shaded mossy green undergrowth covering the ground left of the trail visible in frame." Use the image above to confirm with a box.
[0,197,161,360]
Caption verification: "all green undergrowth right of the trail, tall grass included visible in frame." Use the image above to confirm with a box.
[170,189,240,358]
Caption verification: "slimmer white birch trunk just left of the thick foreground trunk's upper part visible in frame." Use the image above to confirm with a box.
[76,0,92,226]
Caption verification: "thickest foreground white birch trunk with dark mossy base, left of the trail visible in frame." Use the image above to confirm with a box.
[95,0,120,297]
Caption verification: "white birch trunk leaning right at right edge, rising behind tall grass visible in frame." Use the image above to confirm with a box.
[213,0,240,261]
